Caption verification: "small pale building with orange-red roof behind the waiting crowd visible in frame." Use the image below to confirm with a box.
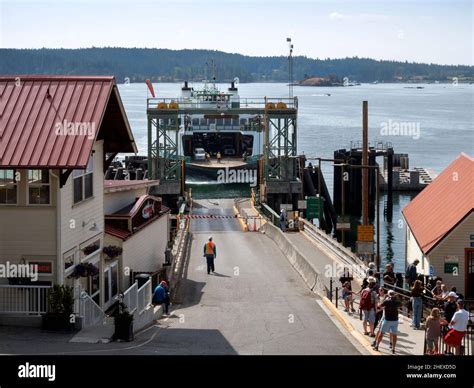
[402,153,474,298]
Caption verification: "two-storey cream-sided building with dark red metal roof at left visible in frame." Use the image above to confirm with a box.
[0,75,147,325]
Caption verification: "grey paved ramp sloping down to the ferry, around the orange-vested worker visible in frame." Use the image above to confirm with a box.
[163,200,359,354]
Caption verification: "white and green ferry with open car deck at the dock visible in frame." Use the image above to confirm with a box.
[177,79,264,175]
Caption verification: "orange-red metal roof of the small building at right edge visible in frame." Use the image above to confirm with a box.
[403,153,474,254]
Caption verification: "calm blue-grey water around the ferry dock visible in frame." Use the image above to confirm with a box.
[119,83,474,271]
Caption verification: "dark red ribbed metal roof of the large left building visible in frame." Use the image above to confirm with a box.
[0,75,136,168]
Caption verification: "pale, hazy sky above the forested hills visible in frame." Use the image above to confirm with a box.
[0,0,474,65]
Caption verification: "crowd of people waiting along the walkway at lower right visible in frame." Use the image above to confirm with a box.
[339,260,469,355]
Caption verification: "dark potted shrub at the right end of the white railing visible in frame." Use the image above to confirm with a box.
[42,284,77,331]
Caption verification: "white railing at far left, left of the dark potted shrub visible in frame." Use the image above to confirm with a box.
[0,285,51,315]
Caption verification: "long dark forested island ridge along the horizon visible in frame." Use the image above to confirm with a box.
[0,47,474,86]
